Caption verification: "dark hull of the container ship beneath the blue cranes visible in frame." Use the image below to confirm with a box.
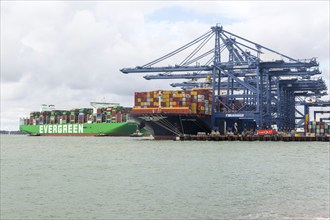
[130,114,211,140]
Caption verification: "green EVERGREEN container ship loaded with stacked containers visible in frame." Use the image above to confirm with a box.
[19,102,147,136]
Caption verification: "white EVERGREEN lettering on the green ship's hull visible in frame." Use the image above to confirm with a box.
[39,124,84,134]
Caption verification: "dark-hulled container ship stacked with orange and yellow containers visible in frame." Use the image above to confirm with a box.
[130,88,255,140]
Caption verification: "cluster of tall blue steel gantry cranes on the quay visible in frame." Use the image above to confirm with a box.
[121,25,327,130]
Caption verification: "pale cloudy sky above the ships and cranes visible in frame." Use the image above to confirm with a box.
[1,1,329,130]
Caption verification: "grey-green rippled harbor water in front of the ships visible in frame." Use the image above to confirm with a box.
[0,135,330,220]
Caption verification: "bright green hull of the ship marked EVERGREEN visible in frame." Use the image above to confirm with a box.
[20,122,145,136]
